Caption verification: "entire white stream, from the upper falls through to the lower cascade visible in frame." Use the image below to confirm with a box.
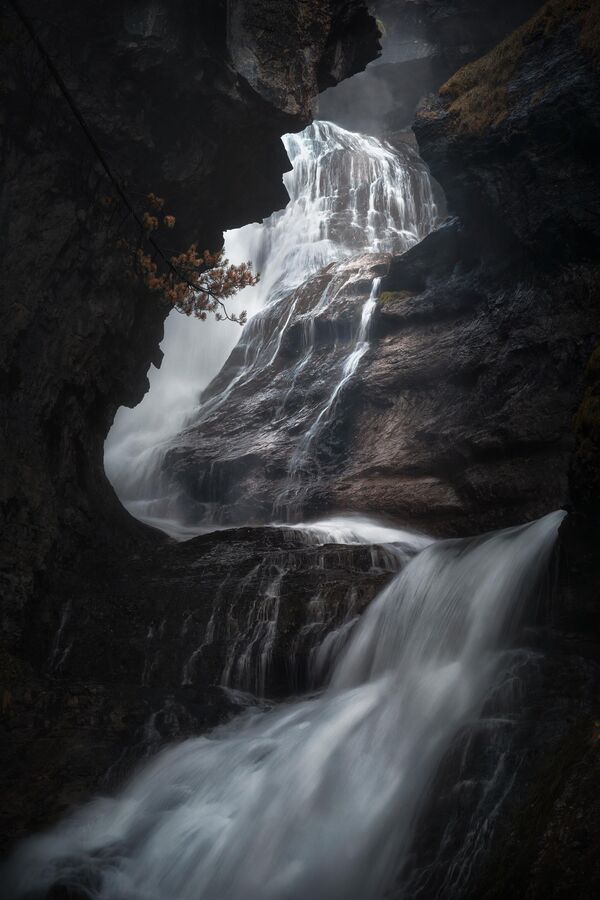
[48,116,562,900]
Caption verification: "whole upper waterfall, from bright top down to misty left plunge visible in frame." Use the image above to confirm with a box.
[105,122,438,536]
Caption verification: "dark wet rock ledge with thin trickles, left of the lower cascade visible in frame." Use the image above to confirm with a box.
[0,528,402,851]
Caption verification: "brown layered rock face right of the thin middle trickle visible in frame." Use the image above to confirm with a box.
[338,229,600,534]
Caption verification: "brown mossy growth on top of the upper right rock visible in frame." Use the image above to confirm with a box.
[440,0,600,134]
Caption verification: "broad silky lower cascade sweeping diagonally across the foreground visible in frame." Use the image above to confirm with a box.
[2,513,563,900]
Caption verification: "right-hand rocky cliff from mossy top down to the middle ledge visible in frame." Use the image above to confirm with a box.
[164,4,600,536]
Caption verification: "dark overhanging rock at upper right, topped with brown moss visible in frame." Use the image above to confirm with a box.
[415,3,600,269]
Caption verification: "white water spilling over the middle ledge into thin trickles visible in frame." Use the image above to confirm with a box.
[182,516,432,698]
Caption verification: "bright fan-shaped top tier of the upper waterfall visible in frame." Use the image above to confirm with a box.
[251,122,437,299]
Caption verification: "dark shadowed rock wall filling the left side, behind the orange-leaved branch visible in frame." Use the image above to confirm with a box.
[0,0,378,845]
